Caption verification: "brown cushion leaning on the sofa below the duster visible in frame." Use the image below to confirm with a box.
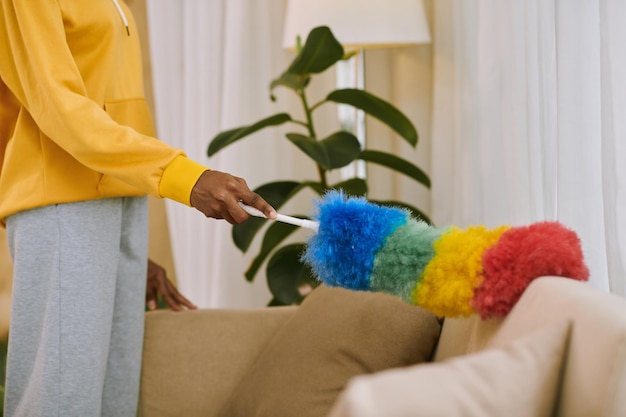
[220,286,440,417]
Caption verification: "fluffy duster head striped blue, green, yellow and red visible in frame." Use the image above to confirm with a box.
[303,191,589,319]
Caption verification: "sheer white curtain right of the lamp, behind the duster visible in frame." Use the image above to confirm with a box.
[432,0,626,295]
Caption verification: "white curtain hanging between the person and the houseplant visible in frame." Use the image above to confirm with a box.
[147,0,292,307]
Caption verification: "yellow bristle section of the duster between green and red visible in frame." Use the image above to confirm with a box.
[412,226,510,317]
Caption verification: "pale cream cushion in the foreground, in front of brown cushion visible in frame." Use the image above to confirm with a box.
[329,322,570,417]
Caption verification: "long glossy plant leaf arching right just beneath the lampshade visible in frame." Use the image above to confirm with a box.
[326,88,417,147]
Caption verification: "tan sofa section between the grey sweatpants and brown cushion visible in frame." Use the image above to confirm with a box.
[139,307,296,417]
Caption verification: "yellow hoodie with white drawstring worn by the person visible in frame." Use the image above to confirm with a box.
[0,0,207,222]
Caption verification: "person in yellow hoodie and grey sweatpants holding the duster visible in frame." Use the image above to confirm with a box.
[0,0,276,417]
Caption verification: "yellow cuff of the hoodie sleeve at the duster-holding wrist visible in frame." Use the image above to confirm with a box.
[159,155,209,206]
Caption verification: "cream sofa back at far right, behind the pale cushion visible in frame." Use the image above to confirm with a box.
[435,277,626,417]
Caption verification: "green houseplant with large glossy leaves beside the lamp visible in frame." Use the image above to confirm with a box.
[207,27,430,305]
